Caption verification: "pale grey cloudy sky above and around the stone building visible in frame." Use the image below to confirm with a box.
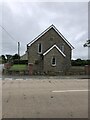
[0,1,88,59]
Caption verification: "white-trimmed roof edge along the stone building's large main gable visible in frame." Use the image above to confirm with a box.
[27,24,74,49]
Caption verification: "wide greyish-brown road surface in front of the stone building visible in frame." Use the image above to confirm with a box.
[2,78,88,118]
